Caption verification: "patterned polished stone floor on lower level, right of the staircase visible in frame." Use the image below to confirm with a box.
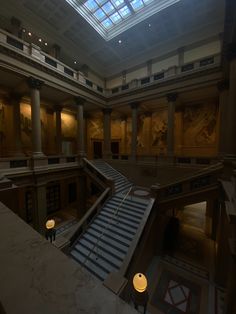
[147,202,220,314]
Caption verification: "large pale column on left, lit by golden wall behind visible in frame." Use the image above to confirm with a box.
[28,77,44,157]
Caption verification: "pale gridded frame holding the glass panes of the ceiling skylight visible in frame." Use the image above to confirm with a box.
[65,0,181,41]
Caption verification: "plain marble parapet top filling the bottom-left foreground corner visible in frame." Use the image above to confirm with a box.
[0,203,137,314]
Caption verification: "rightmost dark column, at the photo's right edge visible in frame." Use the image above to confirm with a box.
[217,80,229,157]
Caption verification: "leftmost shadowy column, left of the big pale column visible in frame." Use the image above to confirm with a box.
[10,93,24,156]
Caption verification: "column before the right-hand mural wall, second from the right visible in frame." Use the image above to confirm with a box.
[166,93,178,157]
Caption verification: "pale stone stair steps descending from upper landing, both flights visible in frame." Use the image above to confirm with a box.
[70,161,153,281]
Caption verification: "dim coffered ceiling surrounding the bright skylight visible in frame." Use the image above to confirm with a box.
[0,0,225,77]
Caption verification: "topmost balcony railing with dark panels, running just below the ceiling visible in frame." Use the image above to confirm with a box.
[0,30,220,97]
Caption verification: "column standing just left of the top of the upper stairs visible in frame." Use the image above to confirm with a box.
[75,97,85,158]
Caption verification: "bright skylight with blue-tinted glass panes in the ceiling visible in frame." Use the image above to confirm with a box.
[66,0,180,41]
